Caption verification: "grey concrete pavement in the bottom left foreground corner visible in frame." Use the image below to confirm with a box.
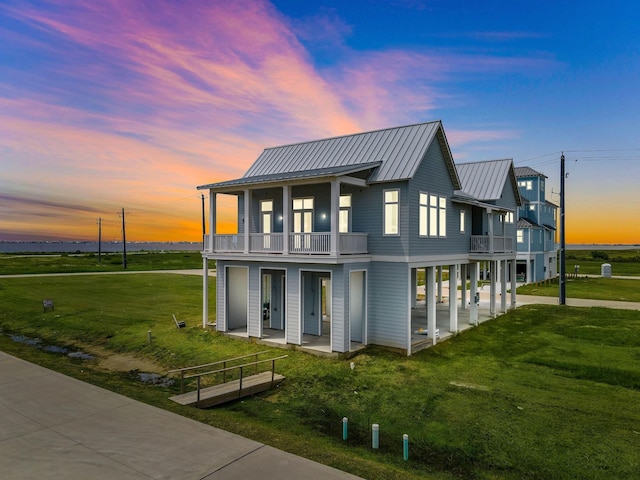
[0,352,358,480]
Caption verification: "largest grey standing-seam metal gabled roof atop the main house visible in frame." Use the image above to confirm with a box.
[243,121,460,189]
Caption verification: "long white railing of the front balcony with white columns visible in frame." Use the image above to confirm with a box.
[205,232,367,255]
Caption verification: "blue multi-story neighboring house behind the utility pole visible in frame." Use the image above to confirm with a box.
[515,167,558,283]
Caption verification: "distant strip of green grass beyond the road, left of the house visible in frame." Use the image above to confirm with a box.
[0,252,205,275]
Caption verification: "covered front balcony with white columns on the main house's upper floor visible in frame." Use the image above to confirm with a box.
[199,162,380,258]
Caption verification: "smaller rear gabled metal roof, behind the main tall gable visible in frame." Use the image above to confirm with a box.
[456,158,522,205]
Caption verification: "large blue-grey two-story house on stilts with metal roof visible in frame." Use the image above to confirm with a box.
[198,121,521,355]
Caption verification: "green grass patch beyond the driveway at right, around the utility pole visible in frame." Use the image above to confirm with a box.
[517,277,640,302]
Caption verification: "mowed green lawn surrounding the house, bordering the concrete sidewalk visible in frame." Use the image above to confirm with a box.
[0,274,640,479]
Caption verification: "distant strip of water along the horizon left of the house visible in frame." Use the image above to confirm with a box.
[0,242,202,253]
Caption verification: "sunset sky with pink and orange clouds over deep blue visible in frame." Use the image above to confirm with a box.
[0,0,640,243]
